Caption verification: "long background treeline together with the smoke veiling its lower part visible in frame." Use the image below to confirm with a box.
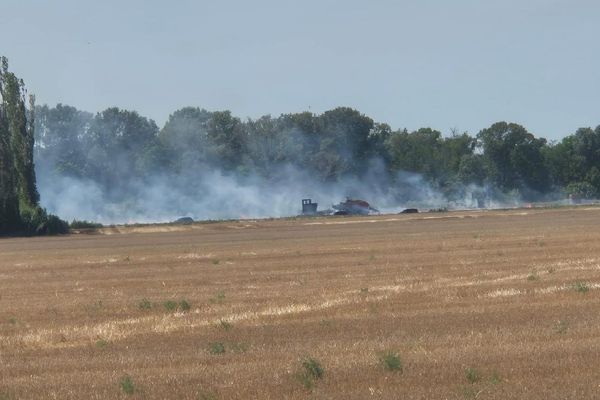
[35,104,600,222]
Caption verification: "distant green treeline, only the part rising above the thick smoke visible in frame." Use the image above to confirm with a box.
[35,104,600,201]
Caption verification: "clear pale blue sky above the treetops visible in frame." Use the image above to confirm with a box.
[0,0,600,139]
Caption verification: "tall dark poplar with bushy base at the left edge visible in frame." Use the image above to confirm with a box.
[0,57,67,234]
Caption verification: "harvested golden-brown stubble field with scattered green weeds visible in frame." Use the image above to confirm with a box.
[0,207,600,399]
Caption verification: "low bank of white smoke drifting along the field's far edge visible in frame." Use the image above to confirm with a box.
[38,160,474,224]
